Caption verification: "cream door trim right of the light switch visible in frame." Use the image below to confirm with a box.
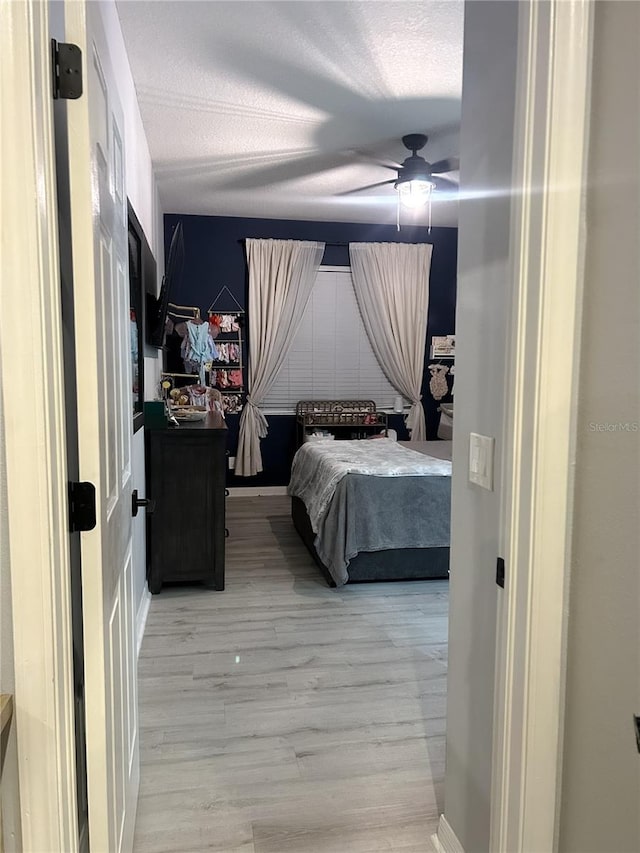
[490,0,592,853]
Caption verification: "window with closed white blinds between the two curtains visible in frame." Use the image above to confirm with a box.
[261,267,398,414]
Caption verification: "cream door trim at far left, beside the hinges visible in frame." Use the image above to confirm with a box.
[0,0,78,853]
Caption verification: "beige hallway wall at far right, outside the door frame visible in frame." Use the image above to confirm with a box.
[559,2,640,853]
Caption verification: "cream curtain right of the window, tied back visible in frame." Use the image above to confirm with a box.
[349,243,433,441]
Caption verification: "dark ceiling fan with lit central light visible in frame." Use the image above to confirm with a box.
[339,133,459,208]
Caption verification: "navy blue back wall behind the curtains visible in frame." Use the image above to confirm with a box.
[164,214,458,486]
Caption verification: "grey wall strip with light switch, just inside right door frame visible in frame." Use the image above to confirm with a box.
[444,2,518,853]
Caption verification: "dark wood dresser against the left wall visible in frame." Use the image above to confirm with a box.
[146,412,227,593]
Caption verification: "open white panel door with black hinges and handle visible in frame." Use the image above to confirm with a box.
[65,0,139,853]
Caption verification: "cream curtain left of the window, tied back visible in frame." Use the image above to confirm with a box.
[235,240,324,477]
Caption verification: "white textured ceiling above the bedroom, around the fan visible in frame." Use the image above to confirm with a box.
[118,0,463,225]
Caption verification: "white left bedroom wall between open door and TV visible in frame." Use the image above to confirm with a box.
[100,0,164,630]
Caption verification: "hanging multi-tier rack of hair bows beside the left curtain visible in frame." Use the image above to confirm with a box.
[207,285,245,414]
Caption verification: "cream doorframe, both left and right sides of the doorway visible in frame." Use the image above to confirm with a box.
[0,0,593,853]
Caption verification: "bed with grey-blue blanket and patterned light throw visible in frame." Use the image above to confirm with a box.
[288,438,451,586]
